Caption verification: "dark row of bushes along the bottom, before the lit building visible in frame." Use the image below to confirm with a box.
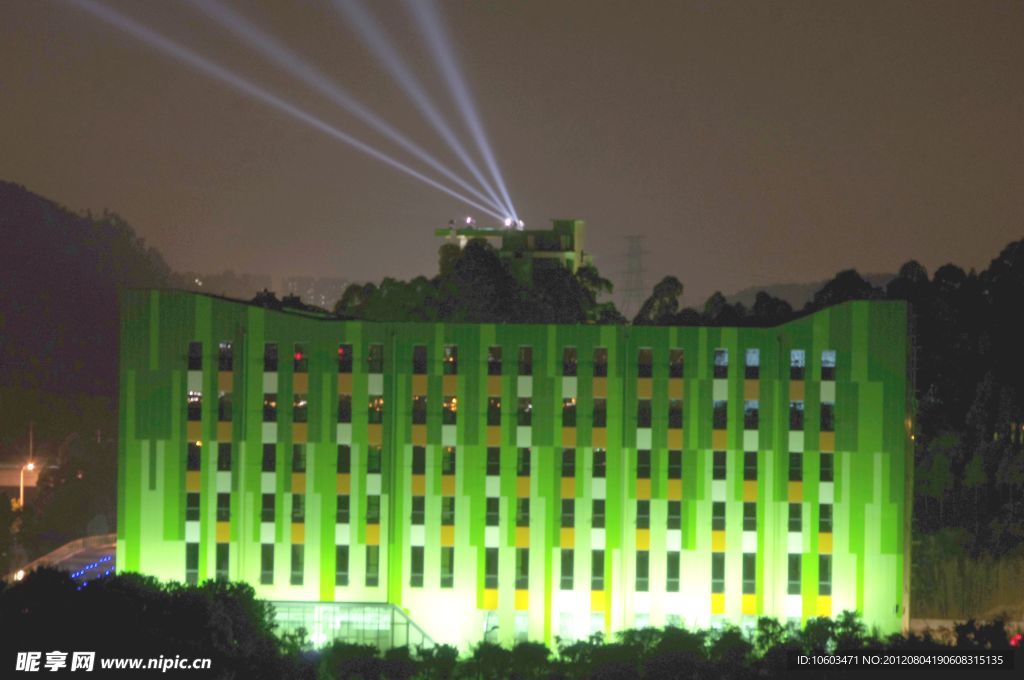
[0,569,1012,680]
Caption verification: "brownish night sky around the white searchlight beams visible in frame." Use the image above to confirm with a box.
[0,0,1024,304]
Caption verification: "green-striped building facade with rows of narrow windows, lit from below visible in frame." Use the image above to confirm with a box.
[117,291,912,648]
